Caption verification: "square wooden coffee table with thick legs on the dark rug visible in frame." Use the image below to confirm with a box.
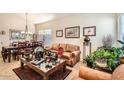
[20,57,66,80]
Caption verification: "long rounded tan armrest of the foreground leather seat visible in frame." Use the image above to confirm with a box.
[79,66,112,80]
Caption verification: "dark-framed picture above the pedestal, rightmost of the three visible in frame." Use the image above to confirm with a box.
[83,26,96,36]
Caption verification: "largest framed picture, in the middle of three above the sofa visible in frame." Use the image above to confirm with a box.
[65,26,80,38]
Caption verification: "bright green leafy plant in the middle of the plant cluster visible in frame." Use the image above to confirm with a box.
[93,47,120,71]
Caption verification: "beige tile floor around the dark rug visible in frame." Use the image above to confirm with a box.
[0,57,83,80]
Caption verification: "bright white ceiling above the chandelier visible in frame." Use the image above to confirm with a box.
[16,13,73,24]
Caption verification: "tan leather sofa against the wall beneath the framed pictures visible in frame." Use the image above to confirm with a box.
[47,43,81,66]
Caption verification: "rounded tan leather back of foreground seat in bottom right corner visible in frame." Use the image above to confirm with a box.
[112,64,124,80]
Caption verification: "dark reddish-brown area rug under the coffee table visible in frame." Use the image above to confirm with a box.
[13,66,72,80]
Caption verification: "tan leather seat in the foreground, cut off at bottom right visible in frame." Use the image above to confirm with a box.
[72,64,124,80]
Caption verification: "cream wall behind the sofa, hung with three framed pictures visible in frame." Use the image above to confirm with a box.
[36,13,116,58]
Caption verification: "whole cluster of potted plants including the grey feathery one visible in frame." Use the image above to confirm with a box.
[84,35,124,72]
